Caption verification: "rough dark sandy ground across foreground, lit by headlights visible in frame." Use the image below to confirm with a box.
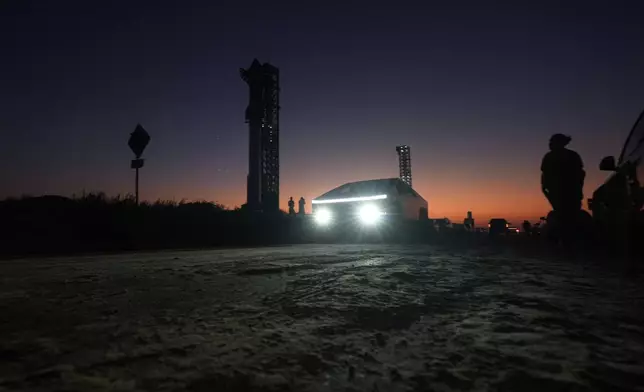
[0,245,644,392]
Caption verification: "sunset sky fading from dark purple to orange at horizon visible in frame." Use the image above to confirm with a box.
[0,0,644,221]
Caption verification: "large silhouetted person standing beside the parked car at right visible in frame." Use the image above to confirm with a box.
[541,133,586,239]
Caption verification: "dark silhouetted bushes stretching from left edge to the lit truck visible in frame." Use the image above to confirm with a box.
[0,193,308,255]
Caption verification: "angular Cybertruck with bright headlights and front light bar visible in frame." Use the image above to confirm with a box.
[311,178,427,228]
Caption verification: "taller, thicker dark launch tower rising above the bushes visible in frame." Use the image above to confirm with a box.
[239,59,280,212]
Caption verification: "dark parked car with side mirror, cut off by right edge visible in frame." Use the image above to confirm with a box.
[588,107,644,248]
